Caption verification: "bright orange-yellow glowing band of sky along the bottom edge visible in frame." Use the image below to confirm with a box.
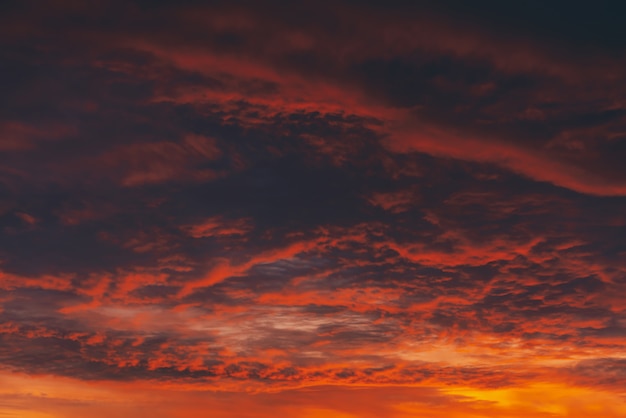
[0,374,626,418]
